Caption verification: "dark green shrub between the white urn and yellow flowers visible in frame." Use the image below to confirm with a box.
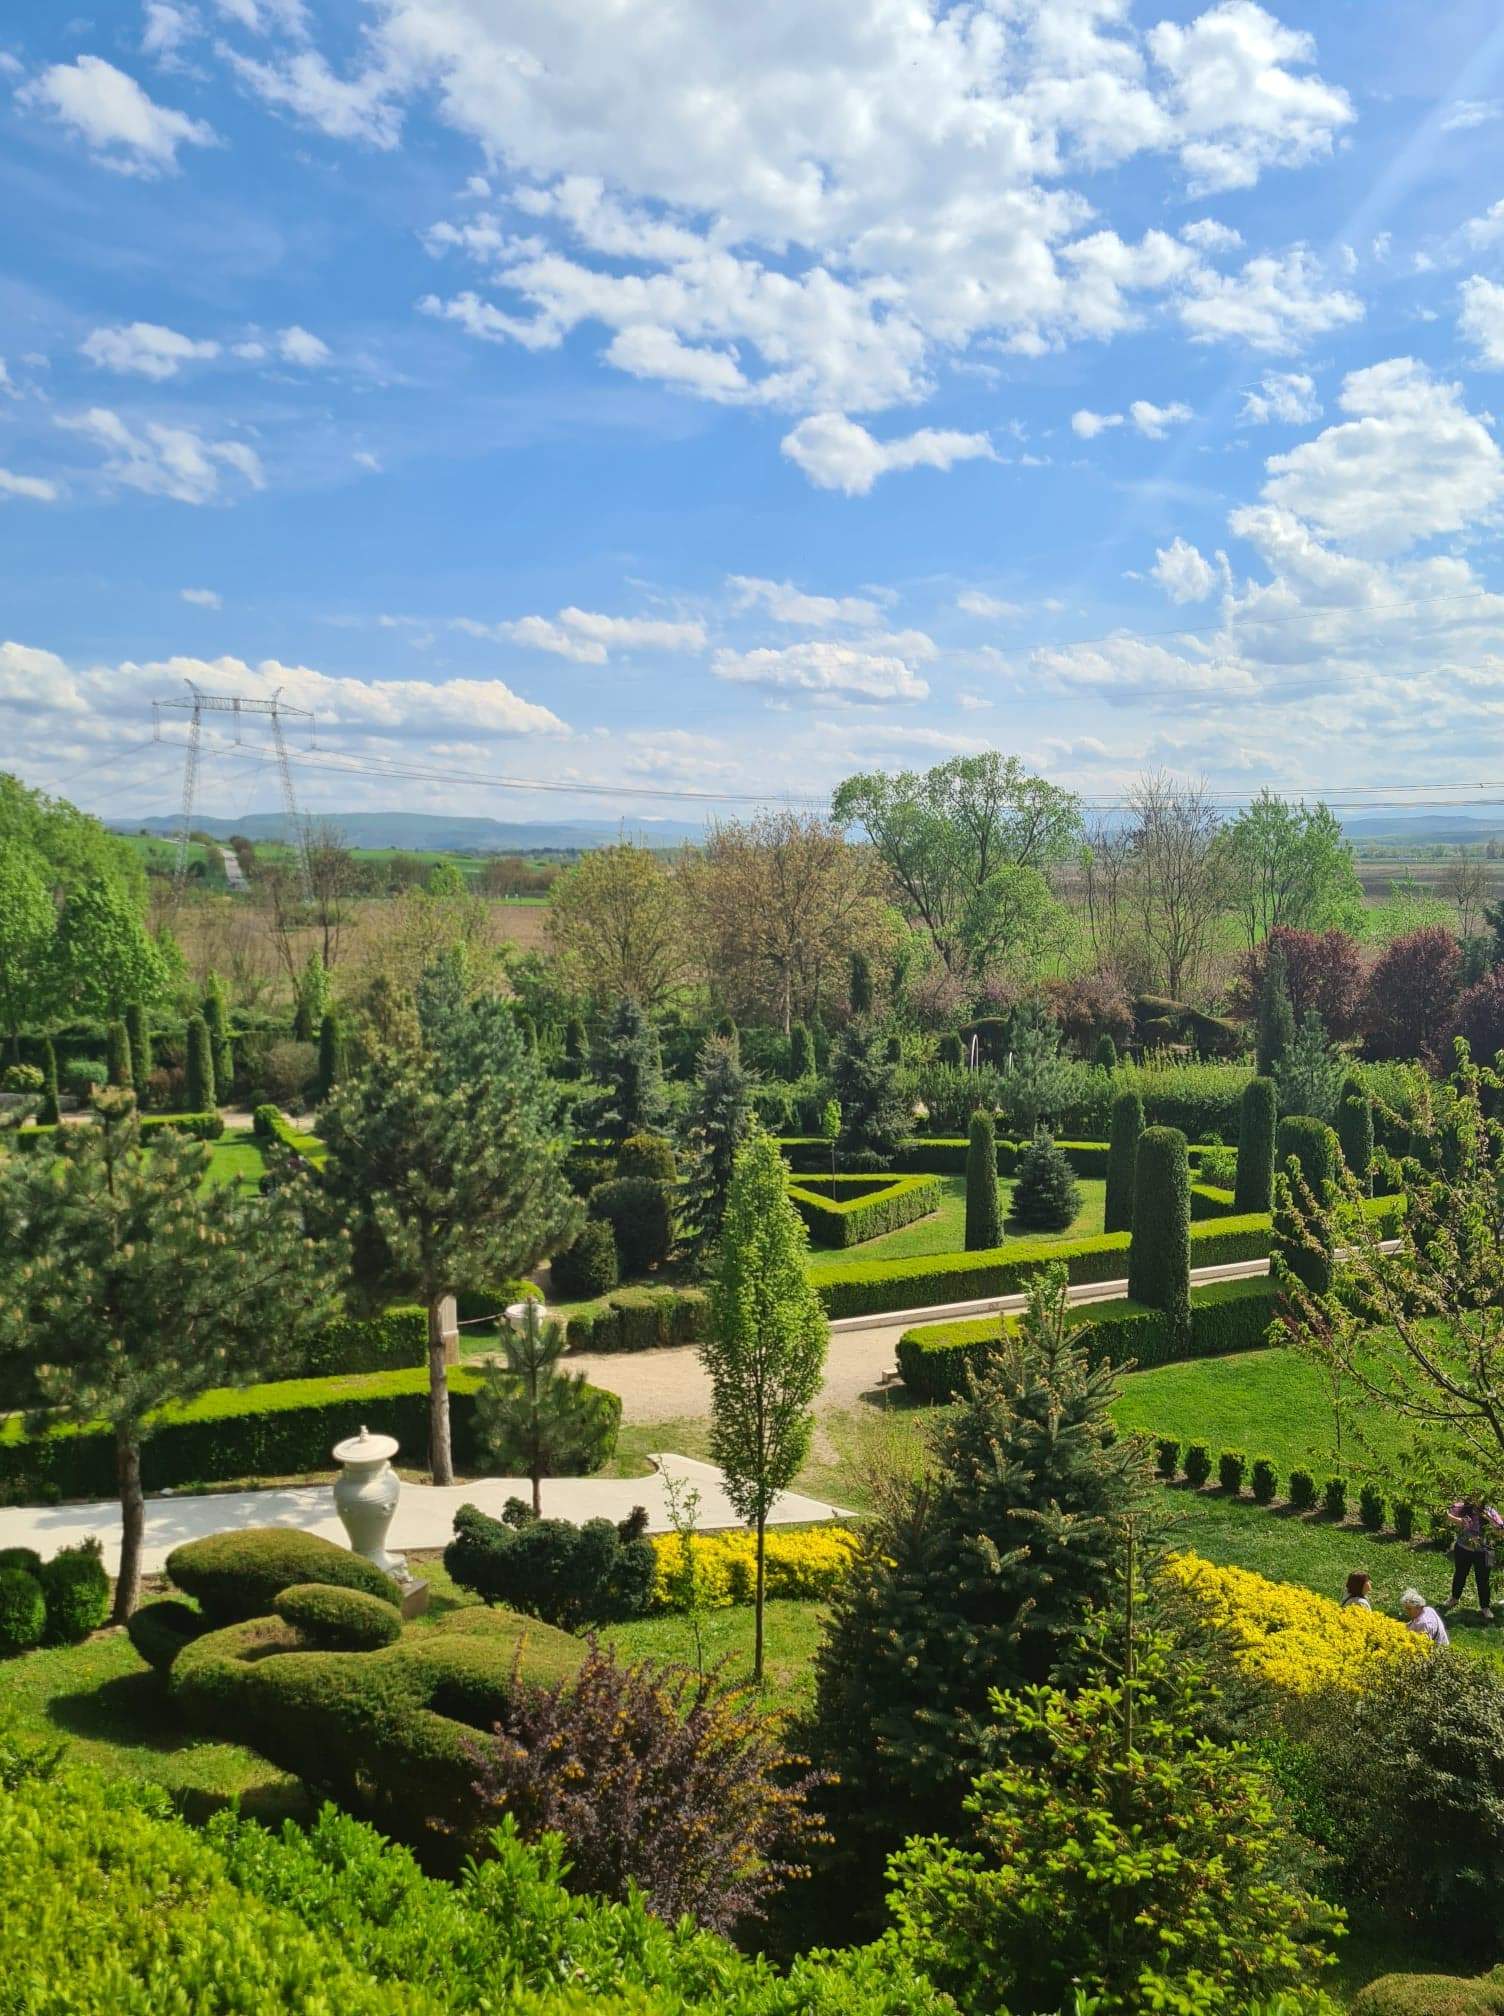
[444,1500,653,1631]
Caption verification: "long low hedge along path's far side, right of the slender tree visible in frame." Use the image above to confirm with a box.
[812,1198,1405,1318]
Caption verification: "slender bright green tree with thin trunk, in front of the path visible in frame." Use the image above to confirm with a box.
[700,1135,829,1683]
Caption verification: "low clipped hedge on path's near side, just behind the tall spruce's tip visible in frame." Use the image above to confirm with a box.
[897,1274,1274,1401]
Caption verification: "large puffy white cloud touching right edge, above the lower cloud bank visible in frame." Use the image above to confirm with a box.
[1264,357,1504,552]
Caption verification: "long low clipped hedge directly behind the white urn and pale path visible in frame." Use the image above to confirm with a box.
[0,1365,621,1502]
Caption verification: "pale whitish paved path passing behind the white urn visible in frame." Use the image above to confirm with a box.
[0,1456,841,1574]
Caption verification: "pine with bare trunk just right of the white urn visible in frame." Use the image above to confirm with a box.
[319,970,583,1484]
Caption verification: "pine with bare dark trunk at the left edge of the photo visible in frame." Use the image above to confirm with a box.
[0,1093,341,1621]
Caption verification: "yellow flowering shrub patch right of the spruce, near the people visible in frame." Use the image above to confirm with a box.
[1163,1554,1429,1695]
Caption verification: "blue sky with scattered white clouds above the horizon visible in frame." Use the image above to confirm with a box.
[0,0,1504,818]
